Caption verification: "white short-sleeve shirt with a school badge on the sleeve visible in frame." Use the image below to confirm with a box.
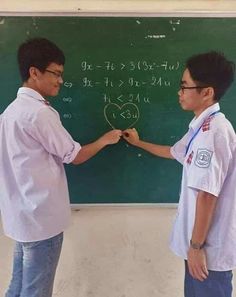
[170,103,236,271]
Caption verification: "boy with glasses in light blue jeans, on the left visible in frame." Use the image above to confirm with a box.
[0,38,122,297]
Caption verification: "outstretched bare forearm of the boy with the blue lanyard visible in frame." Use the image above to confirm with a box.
[136,140,174,159]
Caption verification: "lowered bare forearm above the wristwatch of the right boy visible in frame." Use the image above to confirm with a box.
[192,191,217,244]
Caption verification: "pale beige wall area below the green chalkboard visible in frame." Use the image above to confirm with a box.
[0,207,236,297]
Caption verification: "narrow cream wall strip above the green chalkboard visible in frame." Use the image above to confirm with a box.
[0,0,236,13]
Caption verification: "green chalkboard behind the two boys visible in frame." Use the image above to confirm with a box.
[0,16,236,204]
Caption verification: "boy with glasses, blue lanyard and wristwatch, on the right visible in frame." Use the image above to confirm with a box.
[123,52,236,297]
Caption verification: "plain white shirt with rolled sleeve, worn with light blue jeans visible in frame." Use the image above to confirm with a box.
[0,87,81,242]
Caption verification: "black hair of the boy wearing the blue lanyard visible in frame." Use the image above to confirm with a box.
[186,51,235,101]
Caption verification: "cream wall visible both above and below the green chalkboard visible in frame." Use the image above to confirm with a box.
[0,0,236,297]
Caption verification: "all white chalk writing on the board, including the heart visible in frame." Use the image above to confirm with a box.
[62,59,180,129]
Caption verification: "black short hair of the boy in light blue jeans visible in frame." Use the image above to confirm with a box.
[17,38,65,82]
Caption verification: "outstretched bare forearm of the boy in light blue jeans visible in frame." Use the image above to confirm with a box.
[72,139,105,165]
